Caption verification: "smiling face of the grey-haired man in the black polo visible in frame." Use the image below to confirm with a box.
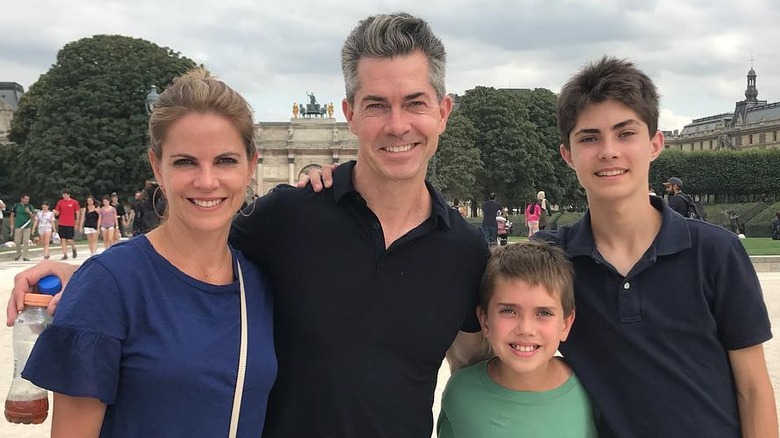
[342,52,452,182]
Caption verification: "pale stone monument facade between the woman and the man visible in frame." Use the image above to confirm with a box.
[254,117,357,195]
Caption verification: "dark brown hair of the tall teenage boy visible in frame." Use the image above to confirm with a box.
[557,56,659,149]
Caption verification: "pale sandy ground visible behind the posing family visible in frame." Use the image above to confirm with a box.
[0,256,780,438]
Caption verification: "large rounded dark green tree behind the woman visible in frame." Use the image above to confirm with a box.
[9,35,196,200]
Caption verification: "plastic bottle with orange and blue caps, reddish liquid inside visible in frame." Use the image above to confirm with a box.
[5,275,62,424]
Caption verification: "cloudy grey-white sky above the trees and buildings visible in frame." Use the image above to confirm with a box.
[6,0,780,130]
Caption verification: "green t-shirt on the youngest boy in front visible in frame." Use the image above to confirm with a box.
[437,361,598,438]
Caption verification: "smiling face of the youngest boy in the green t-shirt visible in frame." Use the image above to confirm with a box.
[477,278,574,387]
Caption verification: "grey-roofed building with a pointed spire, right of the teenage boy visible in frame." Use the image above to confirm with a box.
[664,68,780,151]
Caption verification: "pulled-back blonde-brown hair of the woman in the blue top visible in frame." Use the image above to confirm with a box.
[149,68,257,158]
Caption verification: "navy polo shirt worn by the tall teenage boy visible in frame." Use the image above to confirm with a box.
[536,197,772,438]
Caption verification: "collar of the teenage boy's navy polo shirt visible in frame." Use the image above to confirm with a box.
[566,196,691,257]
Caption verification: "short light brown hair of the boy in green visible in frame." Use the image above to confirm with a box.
[479,241,574,316]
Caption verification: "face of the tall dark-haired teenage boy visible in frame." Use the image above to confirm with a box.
[560,100,664,204]
